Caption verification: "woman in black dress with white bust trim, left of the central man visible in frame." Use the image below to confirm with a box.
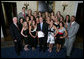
[29,20,37,50]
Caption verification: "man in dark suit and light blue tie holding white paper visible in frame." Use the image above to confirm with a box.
[37,17,48,52]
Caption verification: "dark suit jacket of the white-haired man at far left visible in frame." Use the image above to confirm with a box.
[10,24,21,41]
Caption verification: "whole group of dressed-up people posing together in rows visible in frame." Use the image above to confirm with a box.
[10,7,79,56]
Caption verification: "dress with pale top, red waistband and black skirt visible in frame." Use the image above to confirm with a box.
[55,28,65,45]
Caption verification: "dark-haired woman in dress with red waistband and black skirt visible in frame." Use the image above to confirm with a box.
[55,22,67,52]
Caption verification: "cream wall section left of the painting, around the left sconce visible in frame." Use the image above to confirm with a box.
[17,1,37,14]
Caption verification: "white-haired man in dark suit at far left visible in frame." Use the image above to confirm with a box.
[10,17,22,55]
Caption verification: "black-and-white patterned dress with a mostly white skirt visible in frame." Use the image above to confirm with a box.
[47,27,55,44]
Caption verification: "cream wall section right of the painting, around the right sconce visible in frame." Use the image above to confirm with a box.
[55,1,83,17]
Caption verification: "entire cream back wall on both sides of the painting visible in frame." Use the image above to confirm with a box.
[0,1,83,17]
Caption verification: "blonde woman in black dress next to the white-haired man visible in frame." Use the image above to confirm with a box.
[21,22,29,51]
